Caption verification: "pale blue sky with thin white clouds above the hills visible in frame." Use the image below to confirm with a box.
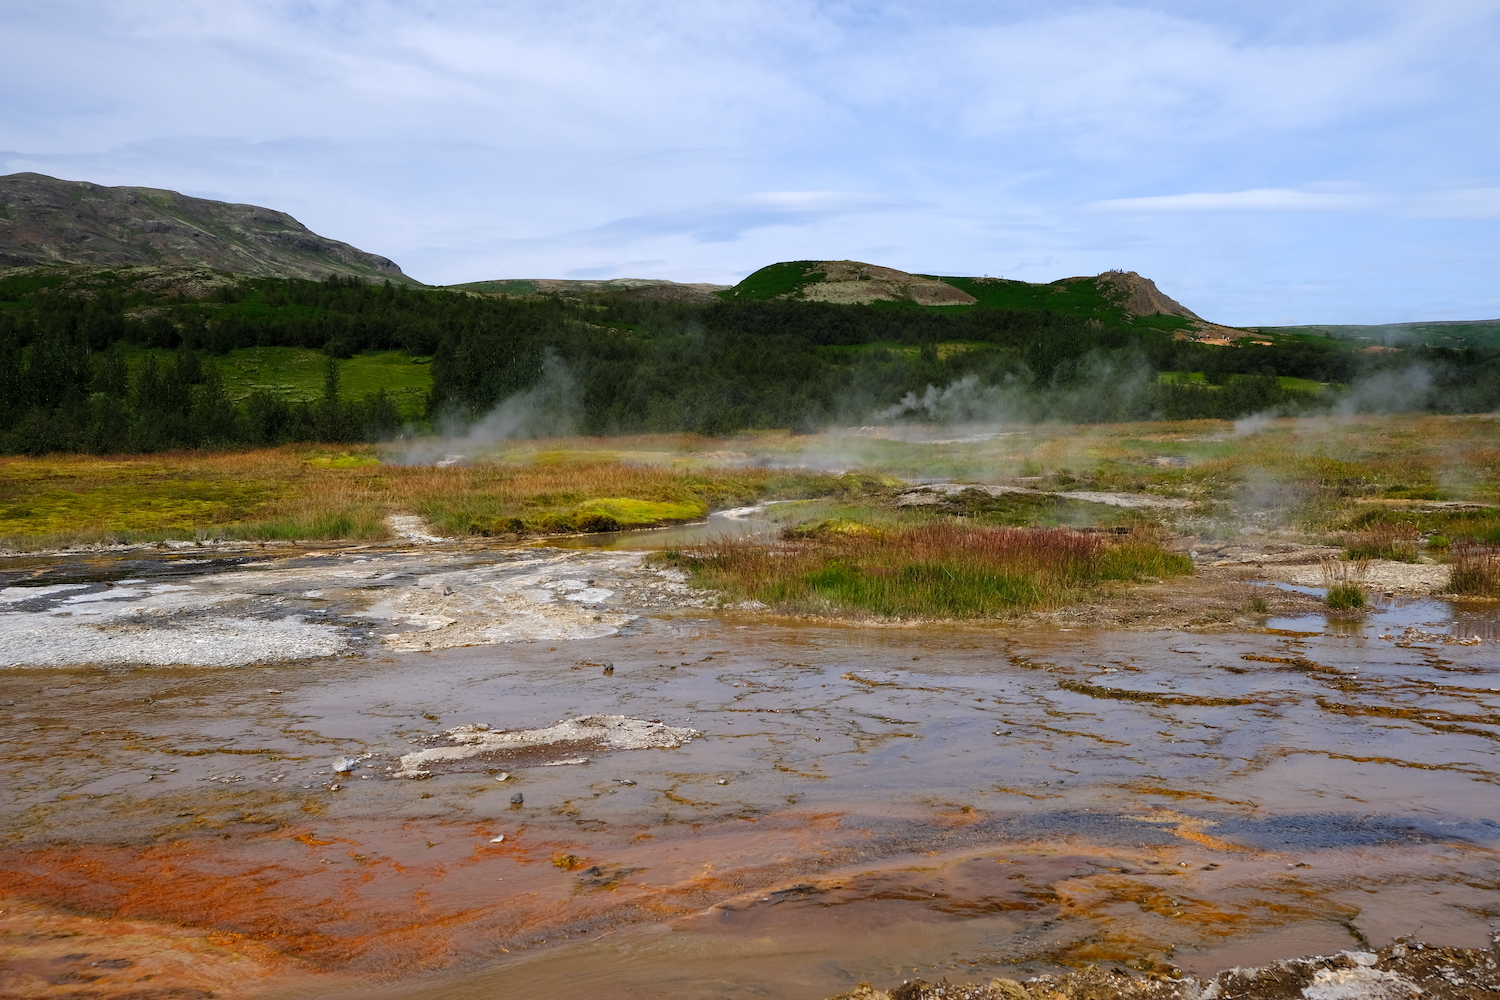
[0,0,1500,325]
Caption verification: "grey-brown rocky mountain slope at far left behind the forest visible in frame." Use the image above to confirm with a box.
[0,174,420,283]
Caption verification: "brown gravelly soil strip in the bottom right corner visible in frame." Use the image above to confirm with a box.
[837,939,1500,1000]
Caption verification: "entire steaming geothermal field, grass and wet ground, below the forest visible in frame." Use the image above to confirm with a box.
[0,417,1500,1000]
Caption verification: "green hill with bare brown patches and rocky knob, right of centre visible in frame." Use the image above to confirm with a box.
[725,261,1251,343]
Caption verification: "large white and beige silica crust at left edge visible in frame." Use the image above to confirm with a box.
[0,546,713,667]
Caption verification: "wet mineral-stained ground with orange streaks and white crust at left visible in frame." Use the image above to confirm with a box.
[0,547,1500,999]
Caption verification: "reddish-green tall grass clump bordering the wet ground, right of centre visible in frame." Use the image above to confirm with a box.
[662,522,1193,618]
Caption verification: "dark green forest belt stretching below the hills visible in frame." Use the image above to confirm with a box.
[0,268,1500,453]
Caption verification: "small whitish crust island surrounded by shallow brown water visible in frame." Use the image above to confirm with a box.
[396,715,702,778]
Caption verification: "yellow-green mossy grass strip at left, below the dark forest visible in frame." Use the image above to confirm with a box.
[0,447,860,550]
